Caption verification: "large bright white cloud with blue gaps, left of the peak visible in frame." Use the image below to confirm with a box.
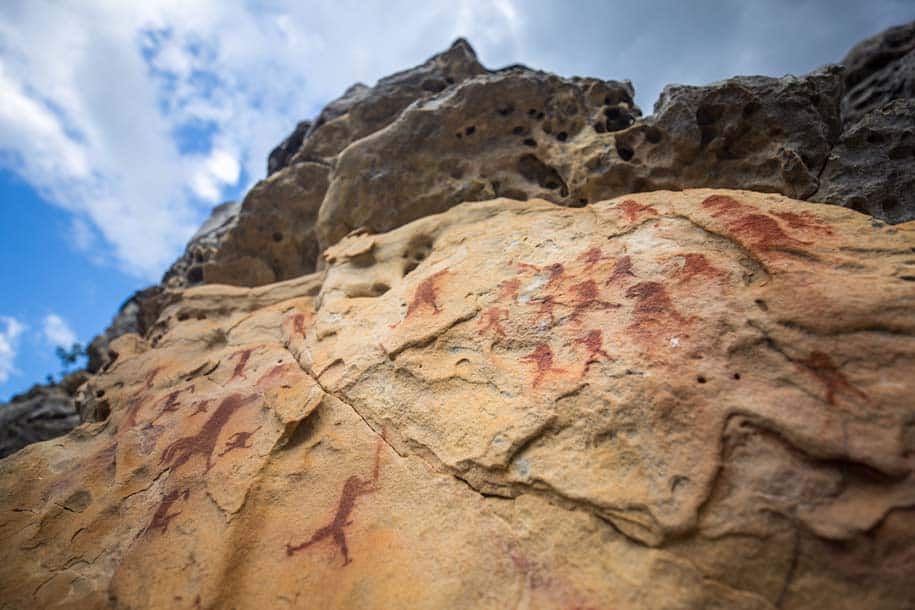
[0,0,518,280]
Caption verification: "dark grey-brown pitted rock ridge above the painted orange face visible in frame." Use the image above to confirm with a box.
[204,24,915,286]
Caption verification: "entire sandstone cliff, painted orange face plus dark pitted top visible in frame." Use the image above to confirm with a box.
[0,20,915,609]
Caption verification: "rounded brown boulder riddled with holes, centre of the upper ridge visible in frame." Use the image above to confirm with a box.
[317,68,641,249]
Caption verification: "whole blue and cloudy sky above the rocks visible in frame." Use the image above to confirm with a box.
[0,0,915,399]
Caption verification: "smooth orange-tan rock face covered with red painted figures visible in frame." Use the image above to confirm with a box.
[0,189,915,610]
